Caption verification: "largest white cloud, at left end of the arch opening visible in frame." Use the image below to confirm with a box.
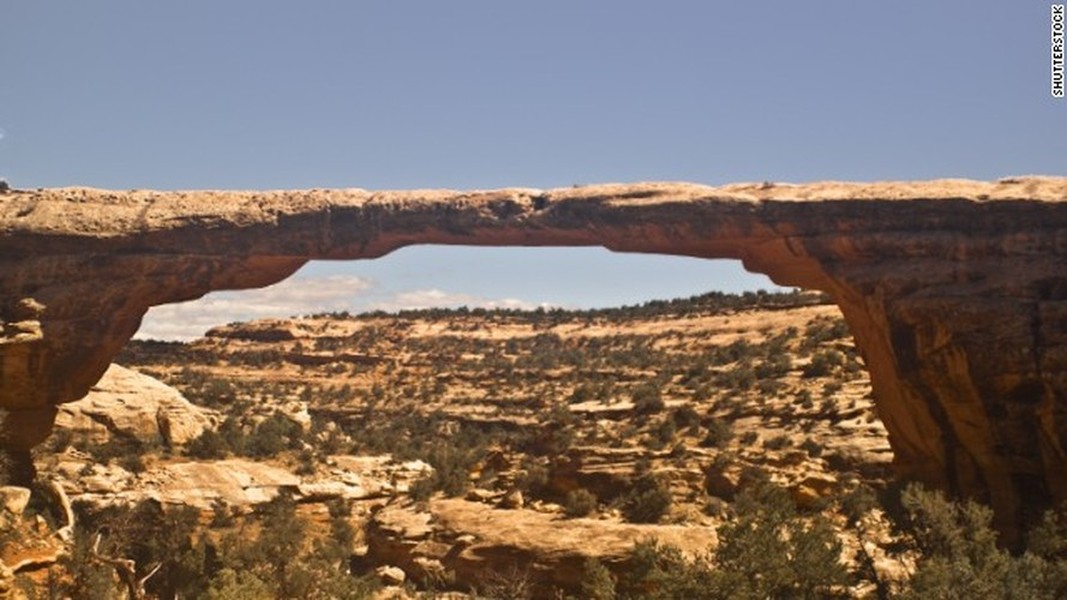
[136,275,371,340]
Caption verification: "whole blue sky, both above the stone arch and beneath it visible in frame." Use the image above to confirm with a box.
[0,0,1067,335]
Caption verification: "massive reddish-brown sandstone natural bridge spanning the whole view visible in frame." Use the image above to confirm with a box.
[0,177,1067,532]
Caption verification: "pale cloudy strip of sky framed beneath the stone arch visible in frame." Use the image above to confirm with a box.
[134,246,786,340]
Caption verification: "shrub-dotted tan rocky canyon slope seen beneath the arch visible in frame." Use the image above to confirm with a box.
[6,293,898,597]
